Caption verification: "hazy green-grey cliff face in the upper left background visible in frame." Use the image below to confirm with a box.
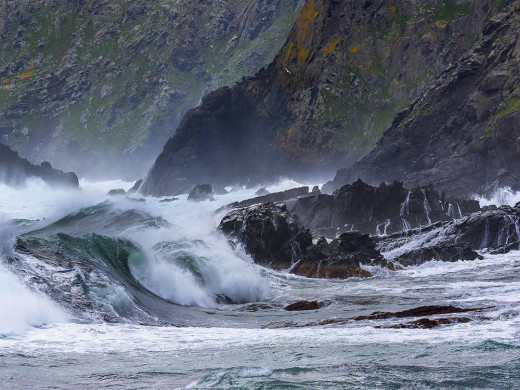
[0,0,302,175]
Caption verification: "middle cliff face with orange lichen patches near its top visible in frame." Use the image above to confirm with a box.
[143,0,500,194]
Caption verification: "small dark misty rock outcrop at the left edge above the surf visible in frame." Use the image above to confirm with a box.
[0,144,79,188]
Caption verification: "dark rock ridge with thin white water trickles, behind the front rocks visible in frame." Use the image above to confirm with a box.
[291,180,480,238]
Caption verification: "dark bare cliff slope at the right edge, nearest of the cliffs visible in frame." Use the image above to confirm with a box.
[327,1,520,195]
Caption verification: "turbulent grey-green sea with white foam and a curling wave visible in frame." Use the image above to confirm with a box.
[0,181,520,389]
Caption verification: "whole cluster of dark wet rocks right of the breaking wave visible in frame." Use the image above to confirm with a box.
[219,180,520,279]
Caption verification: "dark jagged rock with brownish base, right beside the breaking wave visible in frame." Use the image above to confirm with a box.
[219,203,386,279]
